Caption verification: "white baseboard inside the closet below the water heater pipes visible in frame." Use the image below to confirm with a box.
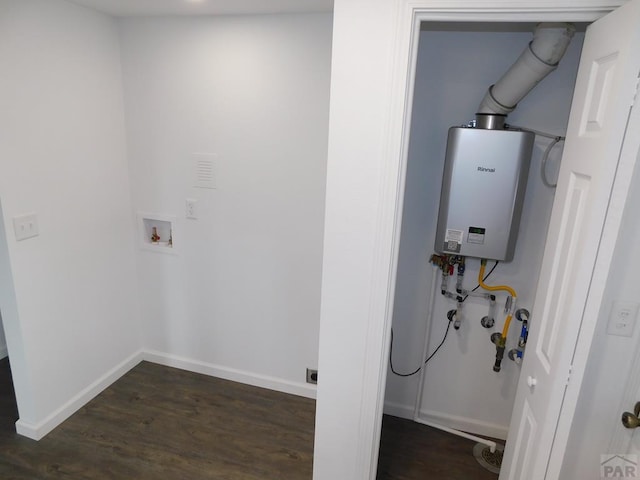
[384,402,509,440]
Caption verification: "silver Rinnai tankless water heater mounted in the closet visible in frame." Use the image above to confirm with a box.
[435,127,535,261]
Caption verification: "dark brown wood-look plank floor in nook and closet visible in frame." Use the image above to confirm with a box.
[0,359,497,480]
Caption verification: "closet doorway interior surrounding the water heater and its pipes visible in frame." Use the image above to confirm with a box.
[378,22,587,479]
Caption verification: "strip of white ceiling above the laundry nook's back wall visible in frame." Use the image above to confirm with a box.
[71,0,333,17]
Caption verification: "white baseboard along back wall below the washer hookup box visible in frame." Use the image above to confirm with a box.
[142,351,316,398]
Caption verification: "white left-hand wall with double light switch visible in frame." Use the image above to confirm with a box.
[0,0,140,436]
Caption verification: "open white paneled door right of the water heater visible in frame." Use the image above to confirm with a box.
[500,0,640,480]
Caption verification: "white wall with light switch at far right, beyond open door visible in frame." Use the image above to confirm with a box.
[561,151,640,478]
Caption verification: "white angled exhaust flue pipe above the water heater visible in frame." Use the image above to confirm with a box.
[478,23,576,115]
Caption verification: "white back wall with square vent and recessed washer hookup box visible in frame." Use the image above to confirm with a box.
[121,14,332,395]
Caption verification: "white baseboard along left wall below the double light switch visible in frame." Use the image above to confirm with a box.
[16,352,142,440]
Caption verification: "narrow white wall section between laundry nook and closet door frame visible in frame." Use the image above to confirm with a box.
[313,0,394,480]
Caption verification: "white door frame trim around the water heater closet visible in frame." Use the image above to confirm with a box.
[356,0,625,479]
